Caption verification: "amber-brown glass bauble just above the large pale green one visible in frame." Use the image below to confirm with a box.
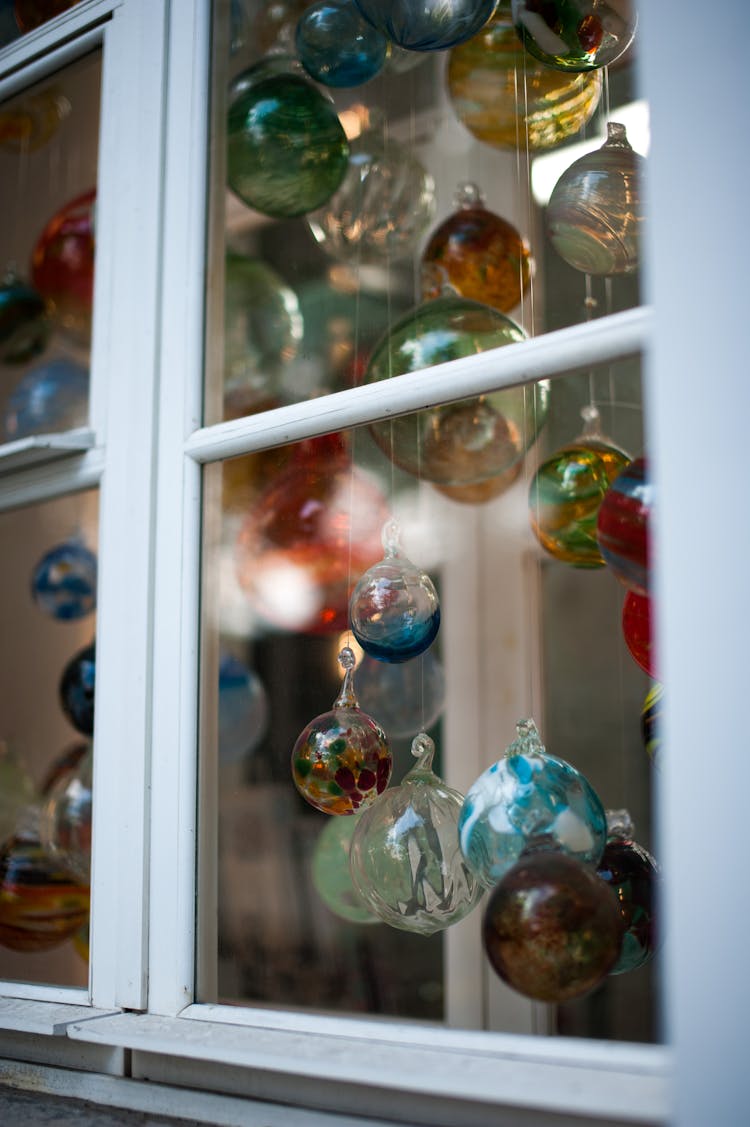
[422,183,533,313]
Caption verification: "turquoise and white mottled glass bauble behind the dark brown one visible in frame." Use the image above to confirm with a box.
[458,720,607,888]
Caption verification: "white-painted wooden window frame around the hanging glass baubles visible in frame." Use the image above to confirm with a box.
[0,0,750,1127]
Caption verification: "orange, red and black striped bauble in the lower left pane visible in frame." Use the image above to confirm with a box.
[0,808,89,951]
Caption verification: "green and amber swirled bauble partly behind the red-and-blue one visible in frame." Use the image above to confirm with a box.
[529,408,630,568]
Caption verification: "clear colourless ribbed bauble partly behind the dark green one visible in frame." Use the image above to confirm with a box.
[309,128,435,266]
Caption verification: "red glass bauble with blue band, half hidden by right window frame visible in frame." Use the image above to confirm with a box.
[597,458,653,595]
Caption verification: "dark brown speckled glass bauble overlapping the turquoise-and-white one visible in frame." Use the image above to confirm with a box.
[483,849,623,1002]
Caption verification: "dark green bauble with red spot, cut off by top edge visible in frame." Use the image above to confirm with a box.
[511,0,637,71]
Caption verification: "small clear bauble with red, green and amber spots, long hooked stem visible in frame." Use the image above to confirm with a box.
[292,646,394,814]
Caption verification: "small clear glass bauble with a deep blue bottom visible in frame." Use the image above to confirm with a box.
[348,521,440,662]
